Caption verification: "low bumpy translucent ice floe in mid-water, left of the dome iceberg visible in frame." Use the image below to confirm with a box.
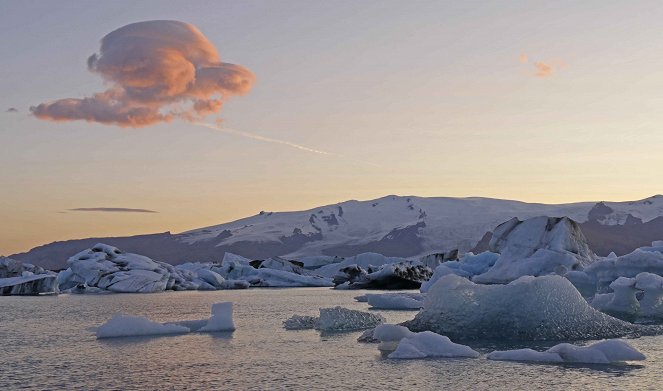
[283,307,385,331]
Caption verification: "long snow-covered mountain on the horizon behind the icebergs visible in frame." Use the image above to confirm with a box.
[12,195,663,267]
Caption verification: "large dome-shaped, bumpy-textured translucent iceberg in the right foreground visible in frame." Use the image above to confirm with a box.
[404,274,663,340]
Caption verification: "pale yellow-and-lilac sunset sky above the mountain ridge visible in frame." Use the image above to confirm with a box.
[0,0,663,255]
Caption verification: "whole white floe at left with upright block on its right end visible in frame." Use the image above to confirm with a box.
[96,302,235,339]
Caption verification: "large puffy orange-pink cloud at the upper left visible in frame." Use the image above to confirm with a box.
[30,20,255,127]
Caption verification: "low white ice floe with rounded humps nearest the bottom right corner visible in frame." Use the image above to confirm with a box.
[487,339,645,364]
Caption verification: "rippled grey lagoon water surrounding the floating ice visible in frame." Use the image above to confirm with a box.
[0,288,663,390]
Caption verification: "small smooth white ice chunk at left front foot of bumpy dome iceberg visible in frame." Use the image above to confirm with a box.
[387,331,479,359]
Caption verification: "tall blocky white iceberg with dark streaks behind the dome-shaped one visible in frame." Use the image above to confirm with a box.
[472,216,596,284]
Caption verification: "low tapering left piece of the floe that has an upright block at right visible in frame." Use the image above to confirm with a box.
[97,314,190,338]
